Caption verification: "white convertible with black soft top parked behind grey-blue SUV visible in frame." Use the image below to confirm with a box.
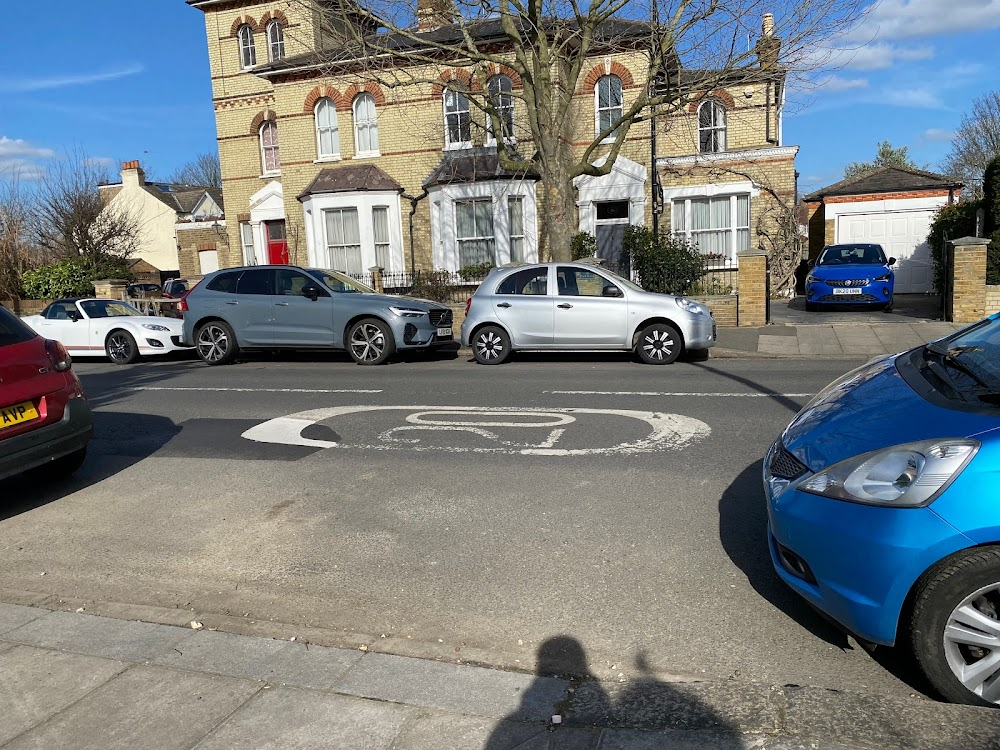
[24,299,191,365]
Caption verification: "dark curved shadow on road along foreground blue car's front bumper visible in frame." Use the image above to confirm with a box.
[719,461,851,650]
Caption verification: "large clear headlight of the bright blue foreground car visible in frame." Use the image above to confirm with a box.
[798,438,980,508]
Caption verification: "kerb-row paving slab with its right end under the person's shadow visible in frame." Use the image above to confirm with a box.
[337,654,568,721]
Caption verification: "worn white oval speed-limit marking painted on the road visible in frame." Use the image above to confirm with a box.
[243,406,712,456]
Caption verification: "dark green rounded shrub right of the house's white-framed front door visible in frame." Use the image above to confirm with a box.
[622,226,706,294]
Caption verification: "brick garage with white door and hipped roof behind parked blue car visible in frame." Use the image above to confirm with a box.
[803,167,963,294]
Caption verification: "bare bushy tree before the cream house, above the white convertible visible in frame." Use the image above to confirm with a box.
[31,154,140,270]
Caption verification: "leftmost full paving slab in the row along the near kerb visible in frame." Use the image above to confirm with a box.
[4,612,194,662]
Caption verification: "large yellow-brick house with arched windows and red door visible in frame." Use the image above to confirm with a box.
[186,0,797,273]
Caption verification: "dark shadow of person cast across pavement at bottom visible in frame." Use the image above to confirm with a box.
[483,636,743,750]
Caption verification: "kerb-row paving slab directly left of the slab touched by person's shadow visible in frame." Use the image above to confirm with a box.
[156,631,362,690]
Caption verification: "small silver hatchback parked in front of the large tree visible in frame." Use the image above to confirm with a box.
[462,262,715,365]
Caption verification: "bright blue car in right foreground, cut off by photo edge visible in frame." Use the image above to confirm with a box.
[764,314,1000,706]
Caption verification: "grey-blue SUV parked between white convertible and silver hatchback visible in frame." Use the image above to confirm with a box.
[179,266,453,365]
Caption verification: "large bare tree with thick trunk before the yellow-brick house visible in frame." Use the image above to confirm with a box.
[297,0,866,260]
